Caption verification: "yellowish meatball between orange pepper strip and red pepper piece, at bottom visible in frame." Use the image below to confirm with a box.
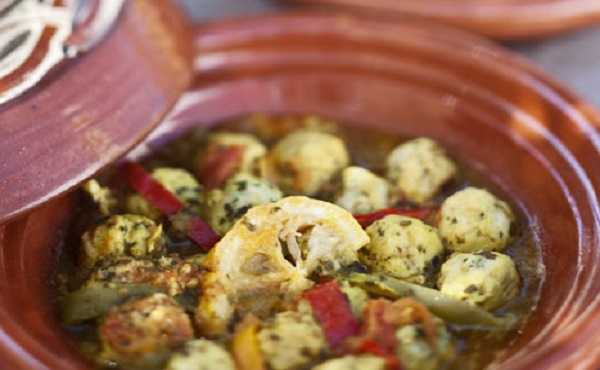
[258,304,327,370]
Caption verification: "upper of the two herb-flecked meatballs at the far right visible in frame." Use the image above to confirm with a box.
[439,187,514,252]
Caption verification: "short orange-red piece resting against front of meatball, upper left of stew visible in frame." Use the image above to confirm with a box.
[198,145,245,189]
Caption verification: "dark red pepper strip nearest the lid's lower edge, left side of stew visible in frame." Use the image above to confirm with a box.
[123,162,183,216]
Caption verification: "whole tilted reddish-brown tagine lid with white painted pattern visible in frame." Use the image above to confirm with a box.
[0,0,192,223]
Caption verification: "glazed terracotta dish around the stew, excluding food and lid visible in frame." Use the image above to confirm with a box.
[0,14,600,370]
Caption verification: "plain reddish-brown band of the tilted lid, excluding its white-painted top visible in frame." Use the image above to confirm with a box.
[0,0,191,222]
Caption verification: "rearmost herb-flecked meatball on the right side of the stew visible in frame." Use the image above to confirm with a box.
[386,138,457,203]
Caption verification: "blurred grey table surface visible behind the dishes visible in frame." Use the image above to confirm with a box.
[180,0,600,107]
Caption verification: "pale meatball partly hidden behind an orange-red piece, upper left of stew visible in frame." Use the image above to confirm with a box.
[199,132,267,176]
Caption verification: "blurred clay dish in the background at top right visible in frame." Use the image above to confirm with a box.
[287,0,600,40]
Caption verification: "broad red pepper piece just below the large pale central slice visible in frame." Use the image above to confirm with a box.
[304,280,360,348]
